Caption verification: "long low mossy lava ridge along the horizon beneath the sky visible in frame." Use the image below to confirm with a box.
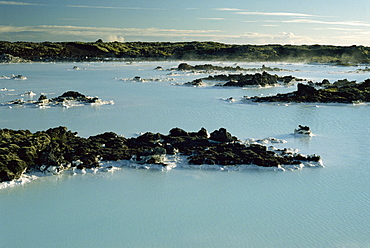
[0,40,370,62]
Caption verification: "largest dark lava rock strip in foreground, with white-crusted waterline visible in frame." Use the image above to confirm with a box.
[0,126,321,182]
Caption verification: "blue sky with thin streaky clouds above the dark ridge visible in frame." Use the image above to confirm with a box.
[0,0,370,46]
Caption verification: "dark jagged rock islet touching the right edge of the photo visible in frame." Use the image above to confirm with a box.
[244,79,370,103]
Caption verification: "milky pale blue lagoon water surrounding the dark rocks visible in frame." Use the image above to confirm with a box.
[0,61,370,248]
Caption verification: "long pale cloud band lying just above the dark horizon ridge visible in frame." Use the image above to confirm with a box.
[0,25,370,45]
